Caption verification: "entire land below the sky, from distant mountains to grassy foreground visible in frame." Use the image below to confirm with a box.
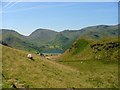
[1,25,120,88]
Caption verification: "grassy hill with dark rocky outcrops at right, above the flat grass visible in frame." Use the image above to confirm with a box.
[62,37,120,60]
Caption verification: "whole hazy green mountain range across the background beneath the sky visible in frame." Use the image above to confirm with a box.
[1,25,118,52]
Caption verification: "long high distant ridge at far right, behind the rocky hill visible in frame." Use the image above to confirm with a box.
[80,25,118,39]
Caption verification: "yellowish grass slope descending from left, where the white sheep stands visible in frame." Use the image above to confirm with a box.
[2,46,94,88]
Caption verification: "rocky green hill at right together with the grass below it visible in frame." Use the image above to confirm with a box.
[57,37,120,88]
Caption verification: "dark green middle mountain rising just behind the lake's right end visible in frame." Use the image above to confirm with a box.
[52,30,80,50]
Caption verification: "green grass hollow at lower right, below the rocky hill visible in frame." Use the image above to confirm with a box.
[58,59,118,88]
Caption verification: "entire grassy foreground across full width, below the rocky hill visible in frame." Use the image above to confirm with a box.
[2,46,118,88]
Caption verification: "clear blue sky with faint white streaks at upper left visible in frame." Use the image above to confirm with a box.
[0,2,118,35]
